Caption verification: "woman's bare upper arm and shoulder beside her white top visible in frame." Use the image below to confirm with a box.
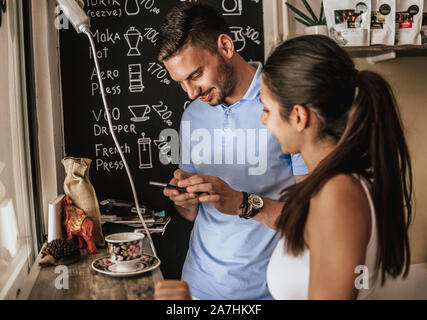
[305,175,374,299]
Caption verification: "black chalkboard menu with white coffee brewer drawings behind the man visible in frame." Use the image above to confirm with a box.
[59,0,264,210]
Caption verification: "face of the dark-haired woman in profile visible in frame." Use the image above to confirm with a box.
[260,79,301,154]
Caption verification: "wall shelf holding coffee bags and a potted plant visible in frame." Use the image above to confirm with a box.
[283,0,427,63]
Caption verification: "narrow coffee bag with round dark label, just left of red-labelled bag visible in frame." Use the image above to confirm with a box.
[371,0,396,46]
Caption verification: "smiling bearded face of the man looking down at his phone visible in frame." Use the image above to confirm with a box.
[163,45,235,106]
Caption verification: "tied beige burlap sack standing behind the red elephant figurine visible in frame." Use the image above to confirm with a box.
[62,157,105,247]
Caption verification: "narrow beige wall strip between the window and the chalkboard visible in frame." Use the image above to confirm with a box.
[32,0,64,233]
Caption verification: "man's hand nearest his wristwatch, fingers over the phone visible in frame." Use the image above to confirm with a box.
[178,174,243,215]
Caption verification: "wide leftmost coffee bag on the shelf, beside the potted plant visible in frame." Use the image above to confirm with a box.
[323,0,371,47]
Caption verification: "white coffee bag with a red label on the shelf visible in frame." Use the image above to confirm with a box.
[396,0,424,45]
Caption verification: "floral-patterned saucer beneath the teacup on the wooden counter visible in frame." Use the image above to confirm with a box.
[91,255,160,277]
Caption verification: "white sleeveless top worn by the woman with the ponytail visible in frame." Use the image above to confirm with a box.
[267,176,378,300]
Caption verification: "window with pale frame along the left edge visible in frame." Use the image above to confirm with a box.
[0,1,37,299]
